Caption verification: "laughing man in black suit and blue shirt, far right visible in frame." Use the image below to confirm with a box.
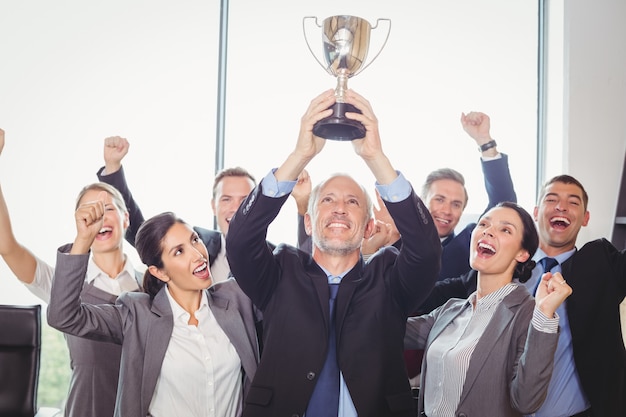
[420,175,626,417]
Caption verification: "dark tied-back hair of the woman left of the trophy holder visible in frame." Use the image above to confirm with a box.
[135,211,186,298]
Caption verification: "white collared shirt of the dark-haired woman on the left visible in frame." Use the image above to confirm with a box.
[149,287,243,417]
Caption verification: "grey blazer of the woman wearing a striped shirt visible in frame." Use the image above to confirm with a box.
[404,286,558,417]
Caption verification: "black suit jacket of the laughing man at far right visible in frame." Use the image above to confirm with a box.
[429,239,626,417]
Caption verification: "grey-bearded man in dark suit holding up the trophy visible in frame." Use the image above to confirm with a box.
[226,90,441,417]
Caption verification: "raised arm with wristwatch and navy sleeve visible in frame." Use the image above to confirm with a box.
[461,112,517,212]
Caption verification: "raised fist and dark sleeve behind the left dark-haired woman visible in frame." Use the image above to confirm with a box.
[97,136,145,247]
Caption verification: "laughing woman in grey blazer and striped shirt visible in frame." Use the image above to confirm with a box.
[405,202,572,417]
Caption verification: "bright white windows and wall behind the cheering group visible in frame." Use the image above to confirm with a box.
[0,0,626,408]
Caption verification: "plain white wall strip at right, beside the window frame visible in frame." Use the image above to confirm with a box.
[552,0,626,243]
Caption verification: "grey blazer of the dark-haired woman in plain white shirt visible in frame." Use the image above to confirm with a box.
[48,245,259,417]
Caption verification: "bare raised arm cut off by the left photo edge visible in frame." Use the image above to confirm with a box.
[0,129,37,284]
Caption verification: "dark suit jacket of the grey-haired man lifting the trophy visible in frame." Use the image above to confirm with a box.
[226,184,441,417]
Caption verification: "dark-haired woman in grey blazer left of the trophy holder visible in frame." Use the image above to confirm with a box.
[48,205,259,417]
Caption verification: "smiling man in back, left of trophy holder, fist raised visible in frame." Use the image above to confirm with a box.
[97,136,258,282]
